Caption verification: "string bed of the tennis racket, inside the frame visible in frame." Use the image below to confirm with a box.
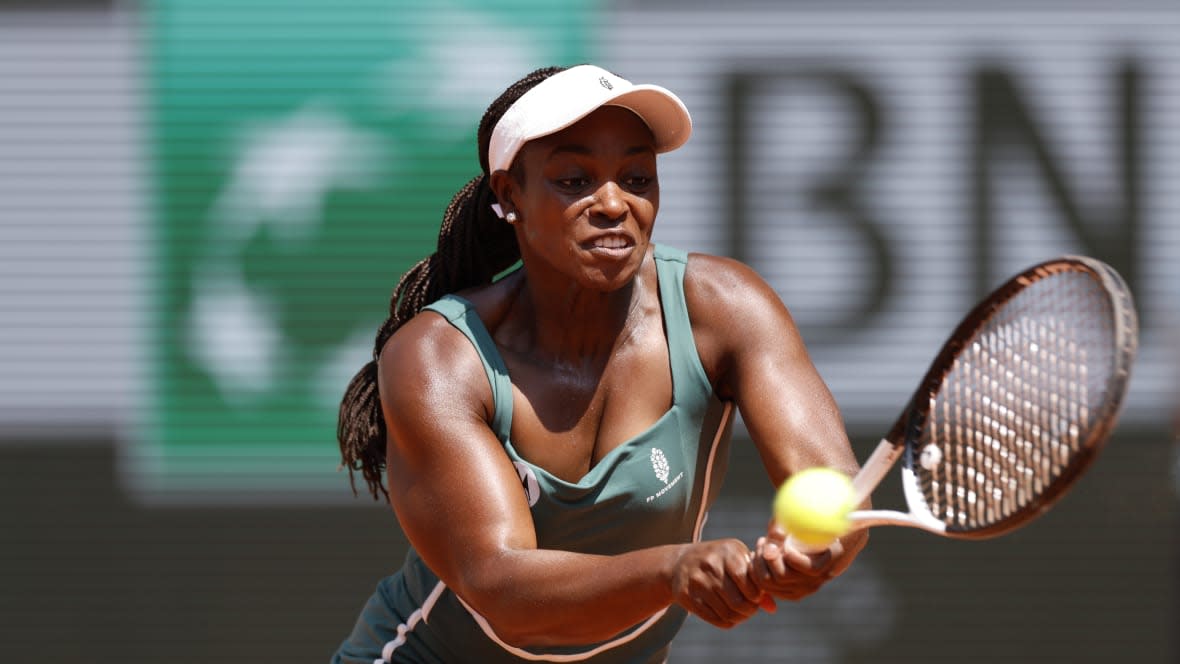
[916,267,1115,531]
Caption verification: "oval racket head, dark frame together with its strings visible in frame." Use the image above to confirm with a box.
[887,256,1139,539]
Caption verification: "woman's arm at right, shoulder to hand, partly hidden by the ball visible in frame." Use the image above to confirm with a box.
[684,254,867,599]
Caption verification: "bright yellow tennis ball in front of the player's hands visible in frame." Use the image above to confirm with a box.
[774,467,856,548]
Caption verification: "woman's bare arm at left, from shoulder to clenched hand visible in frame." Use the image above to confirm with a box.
[380,315,761,645]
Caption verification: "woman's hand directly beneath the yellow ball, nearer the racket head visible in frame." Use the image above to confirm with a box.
[750,524,859,600]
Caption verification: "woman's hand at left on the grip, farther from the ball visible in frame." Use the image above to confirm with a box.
[671,539,773,629]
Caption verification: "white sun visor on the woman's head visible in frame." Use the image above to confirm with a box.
[487,65,693,173]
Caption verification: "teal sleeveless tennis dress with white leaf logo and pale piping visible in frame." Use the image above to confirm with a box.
[333,245,732,664]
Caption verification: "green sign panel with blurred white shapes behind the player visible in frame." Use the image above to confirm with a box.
[129,0,591,495]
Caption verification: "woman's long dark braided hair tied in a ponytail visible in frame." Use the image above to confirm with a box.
[336,67,564,500]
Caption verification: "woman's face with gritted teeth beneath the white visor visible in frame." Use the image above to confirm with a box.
[498,106,660,291]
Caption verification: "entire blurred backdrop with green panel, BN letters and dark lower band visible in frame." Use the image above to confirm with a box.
[0,0,1180,664]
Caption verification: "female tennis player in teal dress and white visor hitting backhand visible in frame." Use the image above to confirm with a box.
[334,65,865,663]
